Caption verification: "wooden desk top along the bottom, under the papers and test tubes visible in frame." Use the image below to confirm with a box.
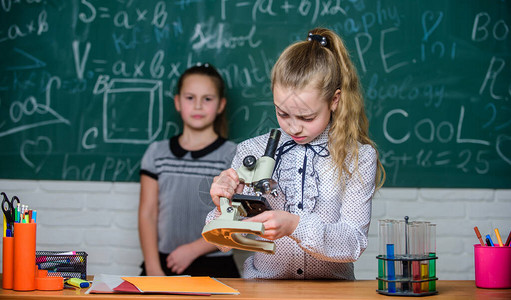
[0,278,511,300]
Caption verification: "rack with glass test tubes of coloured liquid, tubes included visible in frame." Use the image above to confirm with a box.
[376,217,438,296]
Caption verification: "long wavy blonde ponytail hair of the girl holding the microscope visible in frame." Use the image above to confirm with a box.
[272,28,385,188]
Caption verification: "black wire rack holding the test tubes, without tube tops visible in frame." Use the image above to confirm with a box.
[376,255,438,297]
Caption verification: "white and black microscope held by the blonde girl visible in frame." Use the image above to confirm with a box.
[202,129,280,254]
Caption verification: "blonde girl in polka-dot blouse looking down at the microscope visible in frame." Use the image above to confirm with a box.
[208,28,384,280]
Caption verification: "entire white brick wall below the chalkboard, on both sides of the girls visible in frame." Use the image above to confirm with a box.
[0,180,511,280]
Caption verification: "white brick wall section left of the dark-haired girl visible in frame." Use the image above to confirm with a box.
[0,180,142,275]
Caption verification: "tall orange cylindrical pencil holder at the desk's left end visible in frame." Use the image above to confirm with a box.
[13,223,37,291]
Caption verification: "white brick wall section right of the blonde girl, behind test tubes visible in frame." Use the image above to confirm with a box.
[355,188,511,280]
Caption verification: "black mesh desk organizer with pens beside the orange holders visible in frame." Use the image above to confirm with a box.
[36,251,87,280]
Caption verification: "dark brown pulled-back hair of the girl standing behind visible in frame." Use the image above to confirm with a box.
[176,64,229,138]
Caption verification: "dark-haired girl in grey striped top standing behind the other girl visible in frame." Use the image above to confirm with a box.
[138,64,239,277]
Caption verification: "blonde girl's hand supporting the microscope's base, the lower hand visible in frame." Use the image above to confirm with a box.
[243,210,300,240]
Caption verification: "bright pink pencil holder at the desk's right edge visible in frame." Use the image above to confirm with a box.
[474,244,511,289]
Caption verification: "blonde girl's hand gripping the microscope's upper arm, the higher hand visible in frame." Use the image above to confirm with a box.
[209,168,243,210]
